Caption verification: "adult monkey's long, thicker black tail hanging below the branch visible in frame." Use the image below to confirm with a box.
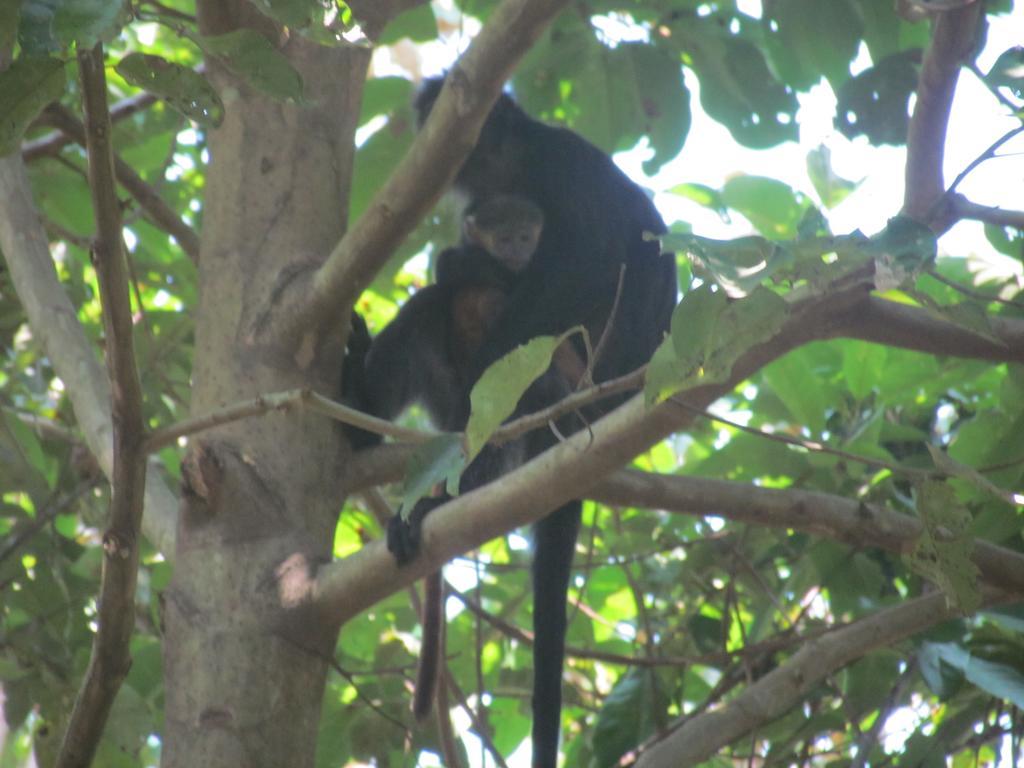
[532,501,581,768]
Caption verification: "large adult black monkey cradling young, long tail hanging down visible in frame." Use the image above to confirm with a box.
[378,79,676,768]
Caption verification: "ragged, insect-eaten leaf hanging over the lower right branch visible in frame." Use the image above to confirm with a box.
[904,481,981,613]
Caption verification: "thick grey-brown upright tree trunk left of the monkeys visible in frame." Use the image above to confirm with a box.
[163,10,369,768]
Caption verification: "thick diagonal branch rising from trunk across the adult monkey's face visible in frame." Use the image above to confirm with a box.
[272,0,566,338]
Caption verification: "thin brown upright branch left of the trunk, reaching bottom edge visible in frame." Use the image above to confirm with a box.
[56,45,145,768]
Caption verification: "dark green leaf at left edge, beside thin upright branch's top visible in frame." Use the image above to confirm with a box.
[0,56,65,157]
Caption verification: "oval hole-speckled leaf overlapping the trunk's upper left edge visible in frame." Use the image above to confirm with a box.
[115,53,224,127]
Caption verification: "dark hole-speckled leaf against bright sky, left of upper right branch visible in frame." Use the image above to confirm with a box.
[836,51,920,145]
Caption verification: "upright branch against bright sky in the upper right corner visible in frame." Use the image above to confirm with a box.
[903,2,984,231]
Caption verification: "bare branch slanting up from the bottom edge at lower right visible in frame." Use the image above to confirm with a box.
[636,591,1008,768]
